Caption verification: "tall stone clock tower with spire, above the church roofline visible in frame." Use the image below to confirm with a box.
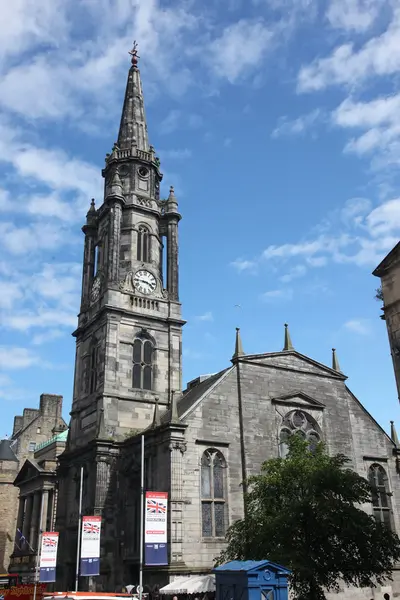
[68,44,184,450]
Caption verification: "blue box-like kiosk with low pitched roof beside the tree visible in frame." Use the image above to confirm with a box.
[213,560,290,600]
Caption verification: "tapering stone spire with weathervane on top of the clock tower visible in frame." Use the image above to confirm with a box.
[117,42,149,152]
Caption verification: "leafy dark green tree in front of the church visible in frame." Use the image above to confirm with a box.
[217,436,400,600]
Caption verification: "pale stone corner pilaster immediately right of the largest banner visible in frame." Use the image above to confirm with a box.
[169,440,186,563]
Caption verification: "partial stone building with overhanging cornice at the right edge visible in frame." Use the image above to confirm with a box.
[373,242,400,400]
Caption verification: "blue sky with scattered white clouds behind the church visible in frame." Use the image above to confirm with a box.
[0,0,400,436]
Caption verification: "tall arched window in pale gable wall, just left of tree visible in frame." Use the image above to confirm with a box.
[201,450,227,537]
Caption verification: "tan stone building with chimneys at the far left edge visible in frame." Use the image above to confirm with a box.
[0,394,67,572]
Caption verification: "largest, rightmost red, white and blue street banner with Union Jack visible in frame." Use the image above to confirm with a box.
[144,492,168,565]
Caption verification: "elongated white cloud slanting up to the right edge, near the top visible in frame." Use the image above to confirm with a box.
[297,8,400,92]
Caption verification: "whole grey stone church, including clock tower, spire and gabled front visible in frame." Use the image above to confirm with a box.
[56,50,400,598]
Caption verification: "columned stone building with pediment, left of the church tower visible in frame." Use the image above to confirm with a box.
[9,429,68,582]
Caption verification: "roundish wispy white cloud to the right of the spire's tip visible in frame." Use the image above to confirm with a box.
[208,19,273,83]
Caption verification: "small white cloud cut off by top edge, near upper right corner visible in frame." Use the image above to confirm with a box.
[326,0,385,32]
